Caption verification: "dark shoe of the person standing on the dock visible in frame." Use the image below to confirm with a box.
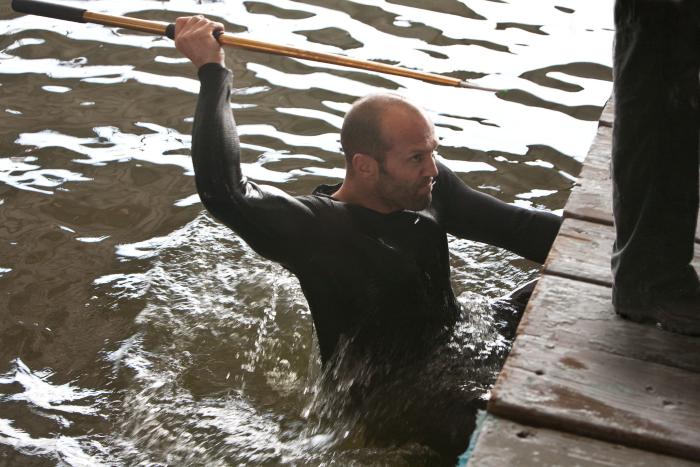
[615,290,700,336]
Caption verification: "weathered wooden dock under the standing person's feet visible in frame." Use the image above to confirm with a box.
[462,102,700,467]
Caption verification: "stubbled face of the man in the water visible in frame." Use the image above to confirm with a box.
[376,107,438,211]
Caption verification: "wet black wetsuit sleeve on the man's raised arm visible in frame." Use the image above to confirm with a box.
[192,63,313,265]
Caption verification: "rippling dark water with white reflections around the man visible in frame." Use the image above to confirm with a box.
[0,0,612,465]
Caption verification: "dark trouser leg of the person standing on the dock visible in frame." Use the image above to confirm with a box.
[612,0,700,306]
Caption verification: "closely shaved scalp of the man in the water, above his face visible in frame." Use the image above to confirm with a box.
[340,94,423,170]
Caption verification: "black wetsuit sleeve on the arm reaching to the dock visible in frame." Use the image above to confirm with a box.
[436,163,562,263]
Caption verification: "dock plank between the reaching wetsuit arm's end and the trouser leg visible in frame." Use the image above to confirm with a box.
[545,219,700,286]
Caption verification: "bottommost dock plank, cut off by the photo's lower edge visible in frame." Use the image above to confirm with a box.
[467,415,699,467]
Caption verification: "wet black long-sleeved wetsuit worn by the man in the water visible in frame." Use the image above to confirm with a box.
[192,64,561,362]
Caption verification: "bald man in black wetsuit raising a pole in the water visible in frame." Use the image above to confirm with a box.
[175,17,561,458]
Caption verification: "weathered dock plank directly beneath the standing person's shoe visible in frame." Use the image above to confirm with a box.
[518,275,700,374]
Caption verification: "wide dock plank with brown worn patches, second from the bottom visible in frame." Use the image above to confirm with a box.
[488,334,700,460]
